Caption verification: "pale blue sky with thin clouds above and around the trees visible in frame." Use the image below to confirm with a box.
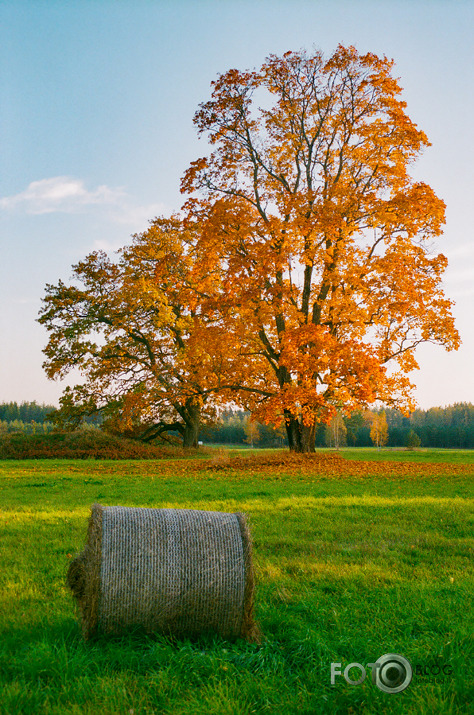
[0,0,474,409]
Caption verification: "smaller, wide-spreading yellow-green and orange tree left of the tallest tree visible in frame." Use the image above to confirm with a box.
[39,217,237,447]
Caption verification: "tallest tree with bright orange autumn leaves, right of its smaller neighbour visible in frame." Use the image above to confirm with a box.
[182,46,459,451]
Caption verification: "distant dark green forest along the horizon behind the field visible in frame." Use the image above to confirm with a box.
[0,402,474,449]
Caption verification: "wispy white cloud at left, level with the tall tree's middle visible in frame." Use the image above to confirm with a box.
[0,176,169,227]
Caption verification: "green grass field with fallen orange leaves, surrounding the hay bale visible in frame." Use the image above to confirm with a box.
[0,450,474,715]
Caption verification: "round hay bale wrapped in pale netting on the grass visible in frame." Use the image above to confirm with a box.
[67,504,259,641]
